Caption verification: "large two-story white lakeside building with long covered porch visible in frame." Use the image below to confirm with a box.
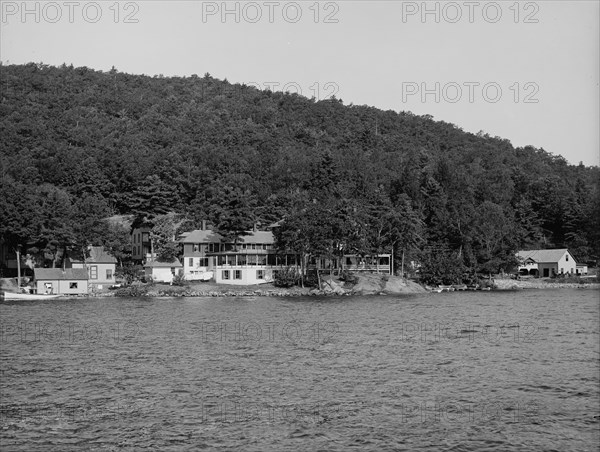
[179,229,392,285]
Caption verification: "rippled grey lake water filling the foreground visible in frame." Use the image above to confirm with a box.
[0,289,600,451]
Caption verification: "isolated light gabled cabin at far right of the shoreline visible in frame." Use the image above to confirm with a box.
[517,248,577,278]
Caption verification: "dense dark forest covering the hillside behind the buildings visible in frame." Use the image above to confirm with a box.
[0,63,600,280]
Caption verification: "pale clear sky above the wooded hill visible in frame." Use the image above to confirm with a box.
[0,0,600,165]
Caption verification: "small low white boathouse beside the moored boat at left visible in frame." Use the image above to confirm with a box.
[33,268,89,295]
